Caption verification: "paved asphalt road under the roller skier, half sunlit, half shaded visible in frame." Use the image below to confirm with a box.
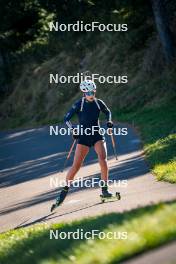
[0,122,176,232]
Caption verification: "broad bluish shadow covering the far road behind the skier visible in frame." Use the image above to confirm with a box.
[0,124,139,188]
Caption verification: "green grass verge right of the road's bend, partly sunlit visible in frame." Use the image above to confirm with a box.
[117,100,176,183]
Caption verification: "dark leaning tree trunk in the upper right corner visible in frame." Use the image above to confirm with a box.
[151,0,175,64]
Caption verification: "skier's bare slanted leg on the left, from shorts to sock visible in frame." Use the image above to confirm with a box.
[66,144,89,185]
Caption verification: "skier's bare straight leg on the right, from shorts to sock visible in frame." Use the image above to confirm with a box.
[94,140,108,181]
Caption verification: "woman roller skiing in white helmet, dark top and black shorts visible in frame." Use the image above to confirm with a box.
[51,80,113,211]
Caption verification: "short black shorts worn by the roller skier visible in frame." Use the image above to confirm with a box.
[78,134,105,148]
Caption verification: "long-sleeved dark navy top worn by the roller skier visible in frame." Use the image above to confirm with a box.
[64,97,111,128]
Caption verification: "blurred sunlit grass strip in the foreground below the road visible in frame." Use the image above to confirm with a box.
[0,201,176,264]
